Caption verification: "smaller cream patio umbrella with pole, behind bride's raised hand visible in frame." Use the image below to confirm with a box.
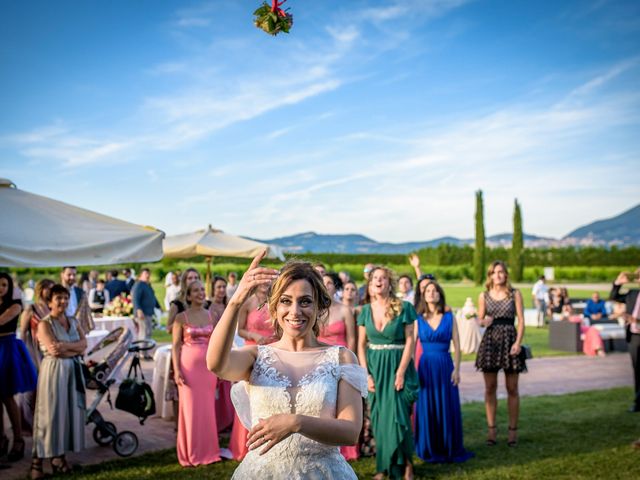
[164,225,284,295]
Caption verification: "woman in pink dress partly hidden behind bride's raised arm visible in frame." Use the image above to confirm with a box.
[229,285,278,462]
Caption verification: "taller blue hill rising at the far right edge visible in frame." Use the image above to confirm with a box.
[562,205,640,245]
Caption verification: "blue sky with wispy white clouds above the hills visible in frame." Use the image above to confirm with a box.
[0,0,640,242]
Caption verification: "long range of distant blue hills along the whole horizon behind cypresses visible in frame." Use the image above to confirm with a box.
[260,205,640,254]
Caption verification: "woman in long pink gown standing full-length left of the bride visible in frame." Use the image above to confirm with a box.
[172,281,220,467]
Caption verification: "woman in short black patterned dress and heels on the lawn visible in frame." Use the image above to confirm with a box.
[476,261,527,447]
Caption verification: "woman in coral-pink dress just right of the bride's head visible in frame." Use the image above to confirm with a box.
[318,272,360,460]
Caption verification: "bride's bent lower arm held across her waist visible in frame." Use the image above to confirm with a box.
[247,349,362,455]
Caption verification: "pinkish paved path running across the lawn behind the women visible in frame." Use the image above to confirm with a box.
[0,353,633,480]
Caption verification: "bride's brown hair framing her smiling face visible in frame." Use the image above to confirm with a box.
[268,260,331,337]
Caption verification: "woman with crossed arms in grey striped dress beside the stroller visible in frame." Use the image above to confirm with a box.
[31,285,87,478]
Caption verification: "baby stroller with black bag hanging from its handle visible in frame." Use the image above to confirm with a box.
[83,327,156,457]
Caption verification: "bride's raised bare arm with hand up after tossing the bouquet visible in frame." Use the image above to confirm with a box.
[207,250,278,381]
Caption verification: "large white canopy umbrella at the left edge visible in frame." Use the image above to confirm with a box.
[0,178,164,267]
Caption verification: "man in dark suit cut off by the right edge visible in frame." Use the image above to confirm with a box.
[609,268,640,412]
